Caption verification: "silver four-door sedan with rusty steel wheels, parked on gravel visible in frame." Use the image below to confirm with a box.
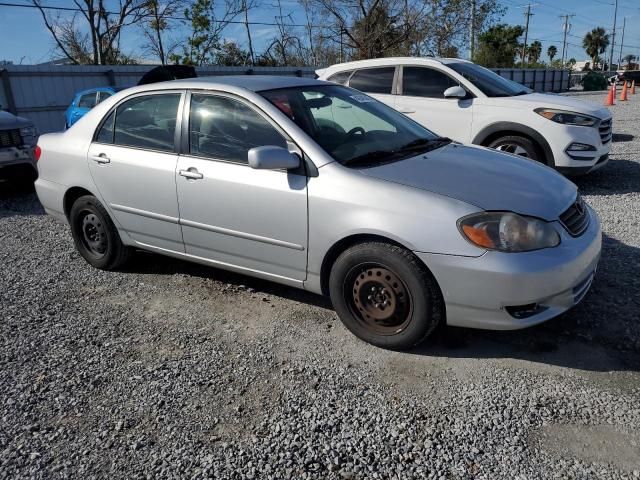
[36,76,601,349]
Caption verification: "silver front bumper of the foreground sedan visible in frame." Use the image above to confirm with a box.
[416,207,602,330]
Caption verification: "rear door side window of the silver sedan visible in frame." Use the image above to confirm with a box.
[111,93,180,152]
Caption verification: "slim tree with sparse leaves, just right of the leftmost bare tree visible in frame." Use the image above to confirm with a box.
[142,0,185,65]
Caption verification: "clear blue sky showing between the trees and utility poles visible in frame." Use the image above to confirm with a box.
[0,0,640,64]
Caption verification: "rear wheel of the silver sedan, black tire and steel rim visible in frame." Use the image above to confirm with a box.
[69,195,132,270]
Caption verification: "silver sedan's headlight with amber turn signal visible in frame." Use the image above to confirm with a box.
[458,212,560,252]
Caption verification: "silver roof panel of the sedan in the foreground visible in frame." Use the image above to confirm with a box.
[149,75,327,92]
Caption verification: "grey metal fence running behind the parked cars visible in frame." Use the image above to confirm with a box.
[0,65,569,133]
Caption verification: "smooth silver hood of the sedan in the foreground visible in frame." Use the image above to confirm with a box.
[360,144,577,221]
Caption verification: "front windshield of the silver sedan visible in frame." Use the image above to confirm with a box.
[260,85,450,166]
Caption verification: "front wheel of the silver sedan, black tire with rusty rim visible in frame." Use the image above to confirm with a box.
[329,242,444,350]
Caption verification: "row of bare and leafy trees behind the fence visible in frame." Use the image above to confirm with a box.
[30,0,634,68]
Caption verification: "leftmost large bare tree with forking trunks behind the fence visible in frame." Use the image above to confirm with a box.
[31,0,148,65]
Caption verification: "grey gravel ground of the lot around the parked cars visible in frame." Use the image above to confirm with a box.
[0,94,640,479]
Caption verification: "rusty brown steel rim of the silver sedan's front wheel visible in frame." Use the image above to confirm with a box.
[344,263,413,335]
